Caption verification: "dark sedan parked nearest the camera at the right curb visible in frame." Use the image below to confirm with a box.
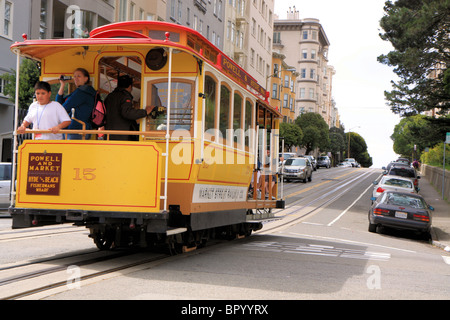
[369,191,434,238]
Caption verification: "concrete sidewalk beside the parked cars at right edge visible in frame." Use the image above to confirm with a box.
[419,176,450,252]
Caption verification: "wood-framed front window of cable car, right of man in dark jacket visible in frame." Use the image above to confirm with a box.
[146,80,194,131]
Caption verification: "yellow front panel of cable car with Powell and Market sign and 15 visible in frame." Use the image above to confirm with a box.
[16,140,162,212]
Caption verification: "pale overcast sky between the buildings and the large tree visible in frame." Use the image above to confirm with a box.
[275,0,400,168]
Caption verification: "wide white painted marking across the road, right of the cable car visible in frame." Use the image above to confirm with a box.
[243,241,391,261]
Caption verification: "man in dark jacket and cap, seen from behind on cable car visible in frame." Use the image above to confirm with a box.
[105,75,153,141]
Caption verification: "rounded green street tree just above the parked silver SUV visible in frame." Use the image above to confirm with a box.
[295,112,330,154]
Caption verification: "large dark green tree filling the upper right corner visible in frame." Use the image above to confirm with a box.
[378,0,450,116]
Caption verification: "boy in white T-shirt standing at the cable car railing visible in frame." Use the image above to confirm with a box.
[17,81,71,140]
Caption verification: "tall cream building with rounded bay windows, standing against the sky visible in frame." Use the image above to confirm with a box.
[273,7,336,127]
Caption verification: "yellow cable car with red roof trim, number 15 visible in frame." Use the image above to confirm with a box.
[10,21,284,249]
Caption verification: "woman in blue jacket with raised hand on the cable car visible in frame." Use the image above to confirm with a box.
[56,68,96,140]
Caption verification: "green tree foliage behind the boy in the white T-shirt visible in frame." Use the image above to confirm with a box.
[0,59,40,109]
